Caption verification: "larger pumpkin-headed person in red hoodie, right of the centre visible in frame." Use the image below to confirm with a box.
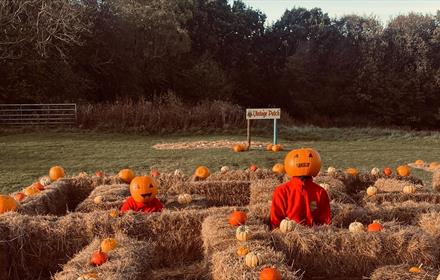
[270,148,331,228]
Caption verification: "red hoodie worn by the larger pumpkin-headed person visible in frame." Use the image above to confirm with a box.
[270,177,331,228]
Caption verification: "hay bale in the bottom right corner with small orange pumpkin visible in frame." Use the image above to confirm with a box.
[370,264,440,280]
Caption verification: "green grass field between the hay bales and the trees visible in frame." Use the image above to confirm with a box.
[0,127,440,193]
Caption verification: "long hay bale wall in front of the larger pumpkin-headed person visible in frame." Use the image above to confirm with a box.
[273,225,439,278]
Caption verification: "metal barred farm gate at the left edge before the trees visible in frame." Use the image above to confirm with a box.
[0,103,77,126]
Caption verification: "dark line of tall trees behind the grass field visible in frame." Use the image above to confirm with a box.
[0,0,440,128]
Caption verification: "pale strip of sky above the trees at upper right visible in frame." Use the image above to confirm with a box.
[230,0,440,24]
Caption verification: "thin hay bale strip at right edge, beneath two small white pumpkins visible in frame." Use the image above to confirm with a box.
[364,192,440,204]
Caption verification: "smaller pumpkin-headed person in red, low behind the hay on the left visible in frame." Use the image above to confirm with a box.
[121,176,163,213]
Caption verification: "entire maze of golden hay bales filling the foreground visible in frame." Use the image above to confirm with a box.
[0,169,440,280]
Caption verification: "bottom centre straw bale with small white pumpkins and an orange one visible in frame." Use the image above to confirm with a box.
[211,241,301,280]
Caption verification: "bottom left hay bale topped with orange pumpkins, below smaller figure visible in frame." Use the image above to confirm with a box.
[53,234,157,280]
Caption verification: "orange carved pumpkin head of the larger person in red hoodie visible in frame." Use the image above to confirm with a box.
[284,148,321,177]
